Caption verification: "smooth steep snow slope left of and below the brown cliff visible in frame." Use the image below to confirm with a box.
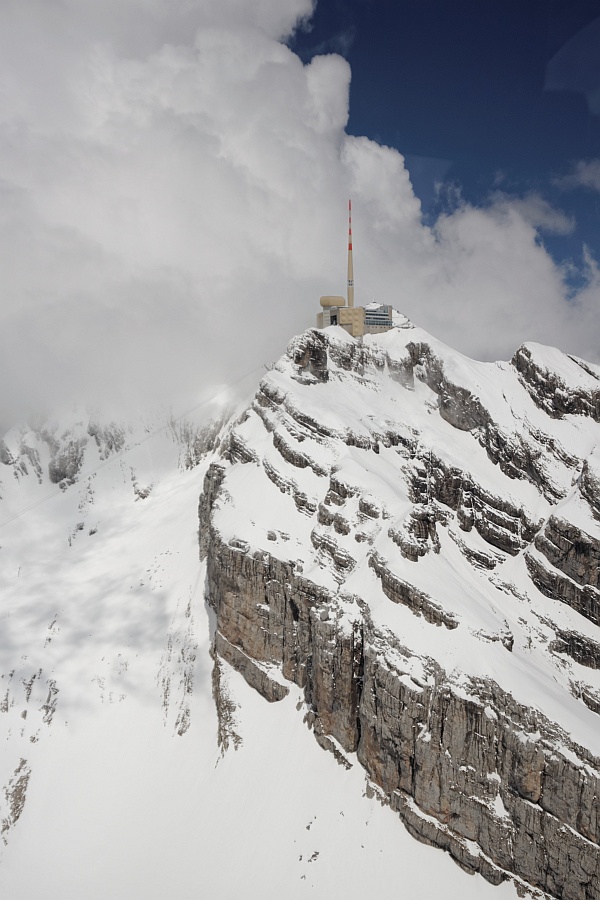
[0,396,516,900]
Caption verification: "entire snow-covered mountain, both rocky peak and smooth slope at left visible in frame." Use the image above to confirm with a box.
[0,320,600,900]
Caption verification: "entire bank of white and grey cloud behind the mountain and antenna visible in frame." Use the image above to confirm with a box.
[0,0,598,424]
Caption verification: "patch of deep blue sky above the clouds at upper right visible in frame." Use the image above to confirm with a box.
[290,0,600,279]
